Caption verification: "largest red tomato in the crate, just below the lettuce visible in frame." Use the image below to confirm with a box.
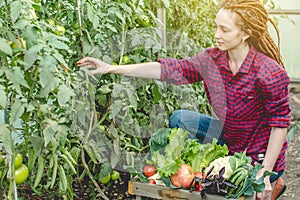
[170,164,195,188]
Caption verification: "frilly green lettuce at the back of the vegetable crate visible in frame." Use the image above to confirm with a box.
[149,128,228,177]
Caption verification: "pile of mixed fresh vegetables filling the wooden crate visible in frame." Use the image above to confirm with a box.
[140,128,273,199]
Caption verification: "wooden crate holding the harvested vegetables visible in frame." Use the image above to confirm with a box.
[128,181,255,200]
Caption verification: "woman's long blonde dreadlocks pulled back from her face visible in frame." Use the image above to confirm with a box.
[220,0,284,67]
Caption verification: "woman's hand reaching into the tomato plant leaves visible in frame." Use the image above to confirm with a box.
[77,57,110,74]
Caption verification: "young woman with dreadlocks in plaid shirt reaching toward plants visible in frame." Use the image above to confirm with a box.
[78,0,290,199]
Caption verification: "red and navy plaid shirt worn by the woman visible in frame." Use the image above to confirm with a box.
[158,47,291,171]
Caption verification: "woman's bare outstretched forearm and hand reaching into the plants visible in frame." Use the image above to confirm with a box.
[77,57,161,79]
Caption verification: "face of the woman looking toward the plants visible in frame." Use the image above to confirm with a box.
[215,9,247,50]
